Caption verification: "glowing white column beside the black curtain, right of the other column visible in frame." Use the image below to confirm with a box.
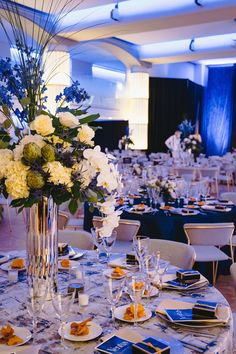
[126,72,149,150]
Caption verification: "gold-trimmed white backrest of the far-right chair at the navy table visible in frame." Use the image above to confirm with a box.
[184,222,234,246]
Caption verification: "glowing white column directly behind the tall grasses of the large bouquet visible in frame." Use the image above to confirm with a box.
[44,50,71,113]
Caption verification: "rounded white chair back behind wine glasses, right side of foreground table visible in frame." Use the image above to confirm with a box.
[149,239,196,269]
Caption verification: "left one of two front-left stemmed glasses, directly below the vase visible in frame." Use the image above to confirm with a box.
[26,278,47,341]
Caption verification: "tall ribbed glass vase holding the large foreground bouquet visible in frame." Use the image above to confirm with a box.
[26,197,58,296]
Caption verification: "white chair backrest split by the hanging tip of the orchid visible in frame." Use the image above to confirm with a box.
[93,216,140,241]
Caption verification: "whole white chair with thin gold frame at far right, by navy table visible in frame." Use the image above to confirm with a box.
[184,222,234,284]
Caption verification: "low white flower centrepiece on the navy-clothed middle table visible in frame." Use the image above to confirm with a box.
[147,177,176,201]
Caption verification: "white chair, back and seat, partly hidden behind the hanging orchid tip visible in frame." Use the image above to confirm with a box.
[93,216,140,253]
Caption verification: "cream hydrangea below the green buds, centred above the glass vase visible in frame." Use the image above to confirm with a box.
[44,161,73,188]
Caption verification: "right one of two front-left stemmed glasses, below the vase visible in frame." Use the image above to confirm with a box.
[50,279,75,349]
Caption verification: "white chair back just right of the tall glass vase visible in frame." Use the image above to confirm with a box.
[58,230,94,250]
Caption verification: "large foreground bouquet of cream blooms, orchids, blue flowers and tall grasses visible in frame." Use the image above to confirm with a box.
[0,0,121,237]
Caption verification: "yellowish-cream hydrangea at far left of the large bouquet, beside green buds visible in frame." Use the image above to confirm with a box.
[5,161,29,199]
